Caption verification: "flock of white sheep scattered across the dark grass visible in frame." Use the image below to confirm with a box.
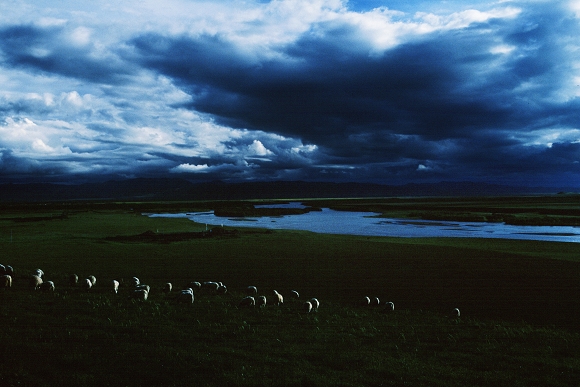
[0,264,460,318]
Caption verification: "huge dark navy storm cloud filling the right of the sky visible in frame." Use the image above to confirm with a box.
[125,1,580,186]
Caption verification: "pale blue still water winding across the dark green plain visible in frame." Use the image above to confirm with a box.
[147,203,580,242]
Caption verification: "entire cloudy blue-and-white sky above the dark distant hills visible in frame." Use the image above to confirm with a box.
[0,0,580,187]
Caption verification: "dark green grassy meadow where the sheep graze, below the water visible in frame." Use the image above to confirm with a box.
[0,203,580,386]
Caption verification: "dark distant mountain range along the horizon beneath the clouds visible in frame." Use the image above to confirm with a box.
[0,178,577,202]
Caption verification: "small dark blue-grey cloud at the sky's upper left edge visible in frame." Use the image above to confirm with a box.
[0,25,130,84]
